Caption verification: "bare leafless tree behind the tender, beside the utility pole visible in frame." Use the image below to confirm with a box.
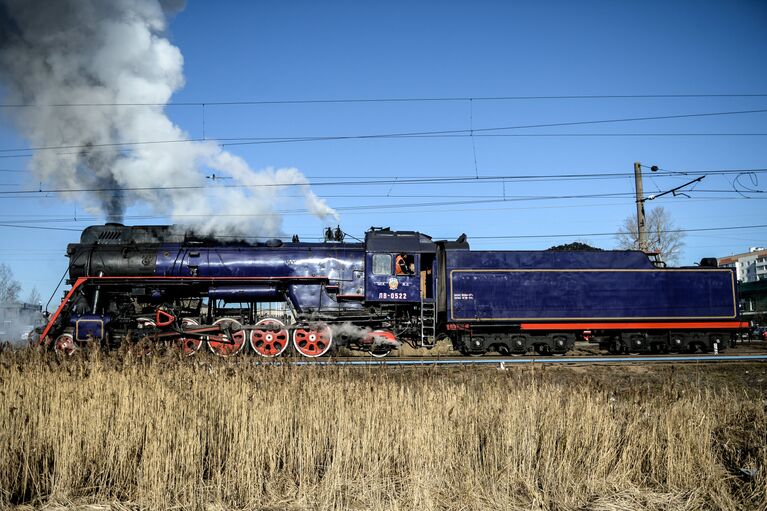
[616,207,684,264]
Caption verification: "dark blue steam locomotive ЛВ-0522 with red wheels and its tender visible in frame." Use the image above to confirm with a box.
[39,224,747,357]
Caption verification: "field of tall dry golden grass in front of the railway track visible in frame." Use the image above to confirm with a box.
[0,352,767,511]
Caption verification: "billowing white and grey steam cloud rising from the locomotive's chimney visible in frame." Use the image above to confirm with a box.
[0,0,337,236]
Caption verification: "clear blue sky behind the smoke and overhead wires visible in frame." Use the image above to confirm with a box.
[0,1,767,302]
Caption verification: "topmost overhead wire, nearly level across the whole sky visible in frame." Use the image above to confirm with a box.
[0,93,767,108]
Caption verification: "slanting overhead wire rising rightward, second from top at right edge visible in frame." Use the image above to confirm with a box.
[0,109,767,157]
